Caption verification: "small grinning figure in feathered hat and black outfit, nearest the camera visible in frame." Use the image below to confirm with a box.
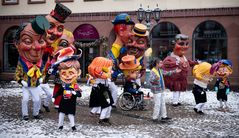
[52,47,81,131]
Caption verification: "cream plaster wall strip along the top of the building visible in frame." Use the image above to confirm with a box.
[0,0,239,16]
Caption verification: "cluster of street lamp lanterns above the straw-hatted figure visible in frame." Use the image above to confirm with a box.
[136,4,161,24]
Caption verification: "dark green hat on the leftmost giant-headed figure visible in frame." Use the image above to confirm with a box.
[31,16,50,34]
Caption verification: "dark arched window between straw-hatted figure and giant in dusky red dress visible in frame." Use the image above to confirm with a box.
[150,22,180,60]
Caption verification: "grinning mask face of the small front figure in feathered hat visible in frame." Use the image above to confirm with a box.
[59,67,81,84]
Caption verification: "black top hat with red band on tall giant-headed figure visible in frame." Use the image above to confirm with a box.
[50,3,71,23]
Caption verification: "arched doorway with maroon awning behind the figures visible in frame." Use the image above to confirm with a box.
[73,24,100,77]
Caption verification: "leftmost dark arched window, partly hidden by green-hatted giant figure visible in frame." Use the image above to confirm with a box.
[3,26,19,72]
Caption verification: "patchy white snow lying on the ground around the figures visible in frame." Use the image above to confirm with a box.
[0,84,239,138]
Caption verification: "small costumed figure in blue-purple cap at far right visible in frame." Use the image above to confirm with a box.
[214,59,233,111]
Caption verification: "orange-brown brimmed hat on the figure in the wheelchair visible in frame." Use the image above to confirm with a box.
[119,55,140,70]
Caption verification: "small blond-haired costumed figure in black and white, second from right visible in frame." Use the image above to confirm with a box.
[192,62,214,115]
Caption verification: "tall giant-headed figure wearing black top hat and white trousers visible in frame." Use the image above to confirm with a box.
[40,3,74,112]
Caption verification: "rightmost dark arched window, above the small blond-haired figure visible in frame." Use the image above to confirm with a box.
[193,21,227,63]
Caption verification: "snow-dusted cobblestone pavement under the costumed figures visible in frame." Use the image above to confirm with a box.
[0,83,239,138]
